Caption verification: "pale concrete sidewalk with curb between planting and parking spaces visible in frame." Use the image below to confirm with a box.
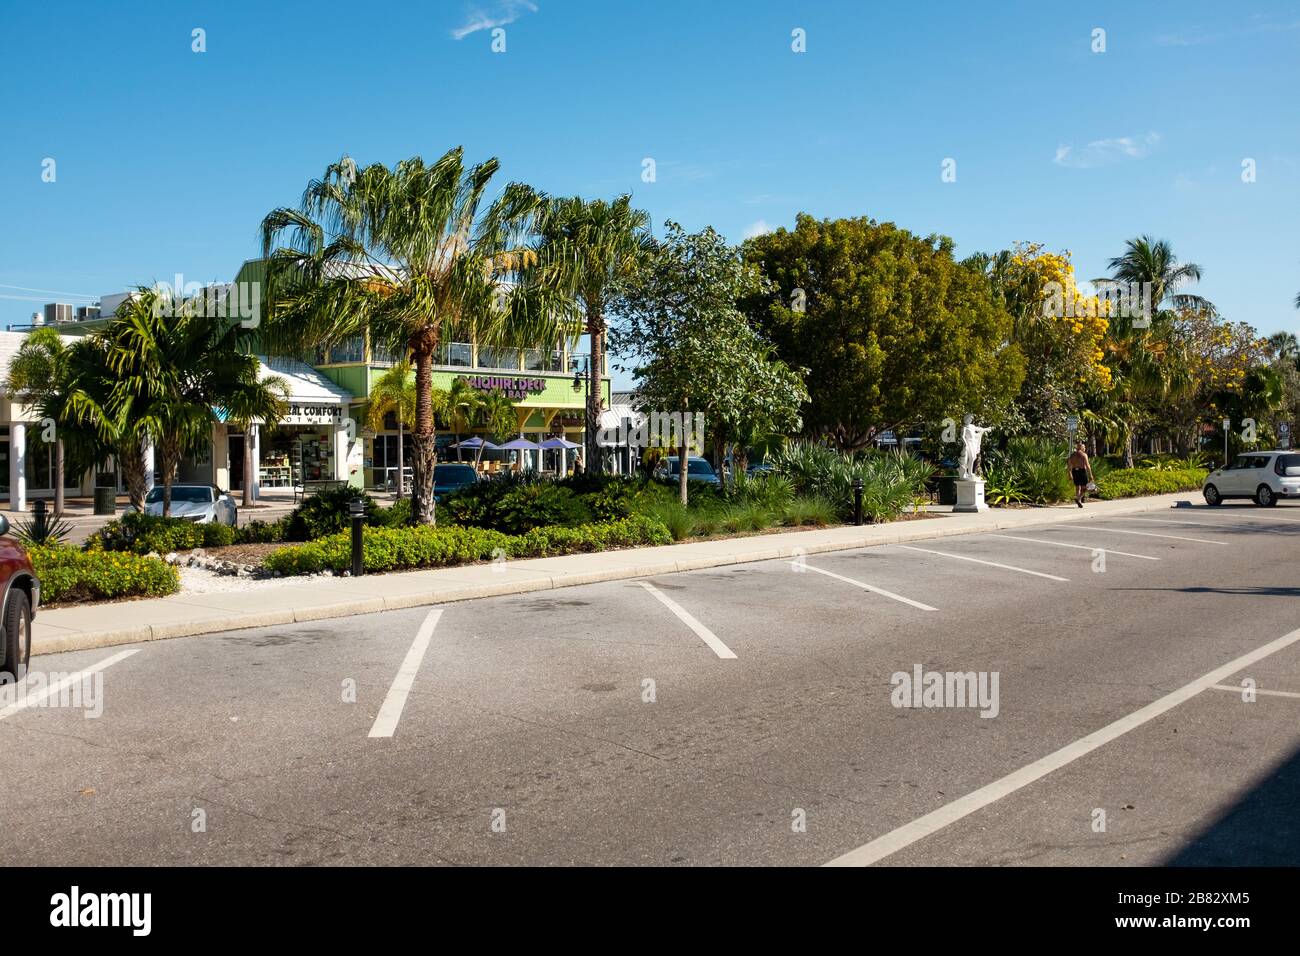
[33,492,1199,654]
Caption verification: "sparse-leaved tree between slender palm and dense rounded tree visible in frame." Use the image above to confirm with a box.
[611,221,807,503]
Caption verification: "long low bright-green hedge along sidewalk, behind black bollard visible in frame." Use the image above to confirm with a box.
[263,516,672,575]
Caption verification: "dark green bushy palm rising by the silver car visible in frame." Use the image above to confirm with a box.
[107,289,287,516]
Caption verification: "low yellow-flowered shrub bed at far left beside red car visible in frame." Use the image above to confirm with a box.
[27,545,181,604]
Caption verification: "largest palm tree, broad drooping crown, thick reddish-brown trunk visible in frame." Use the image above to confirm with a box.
[261,147,572,523]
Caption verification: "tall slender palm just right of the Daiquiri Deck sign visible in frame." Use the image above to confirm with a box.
[538,195,653,470]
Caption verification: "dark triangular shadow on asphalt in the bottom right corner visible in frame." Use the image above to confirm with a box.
[1165,748,1300,866]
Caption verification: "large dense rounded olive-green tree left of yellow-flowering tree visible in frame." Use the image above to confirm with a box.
[745,215,1023,450]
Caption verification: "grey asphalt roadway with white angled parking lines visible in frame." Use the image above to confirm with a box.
[0,505,1300,865]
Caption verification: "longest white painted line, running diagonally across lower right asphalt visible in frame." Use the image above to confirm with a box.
[827,630,1300,866]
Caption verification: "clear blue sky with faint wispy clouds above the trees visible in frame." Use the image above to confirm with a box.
[0,0,1300,390]
